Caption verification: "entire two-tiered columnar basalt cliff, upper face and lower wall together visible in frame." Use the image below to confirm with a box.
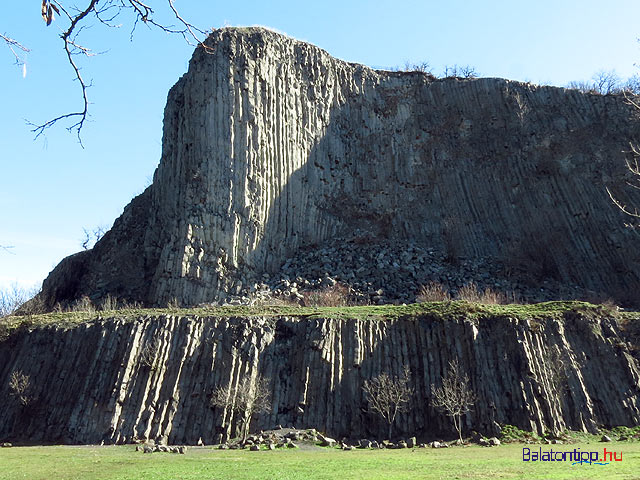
[0,28,640,443]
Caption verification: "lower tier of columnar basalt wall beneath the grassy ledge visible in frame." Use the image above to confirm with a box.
[0,309,640,444]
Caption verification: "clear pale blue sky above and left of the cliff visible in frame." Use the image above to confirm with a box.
[0,0,640,287]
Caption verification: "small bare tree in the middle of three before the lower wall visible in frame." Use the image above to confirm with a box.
[362,366,413,439]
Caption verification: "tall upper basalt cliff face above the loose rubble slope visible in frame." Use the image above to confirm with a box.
[42,28,640,308]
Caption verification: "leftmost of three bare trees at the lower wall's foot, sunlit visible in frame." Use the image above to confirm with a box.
[211,376,271,442]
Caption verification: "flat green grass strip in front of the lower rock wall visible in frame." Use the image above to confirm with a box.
[0,442,640,480]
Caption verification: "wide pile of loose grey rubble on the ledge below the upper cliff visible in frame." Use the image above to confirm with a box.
[222,236,594,305]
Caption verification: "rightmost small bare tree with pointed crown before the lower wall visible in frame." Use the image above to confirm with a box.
[431,358,476,441]
